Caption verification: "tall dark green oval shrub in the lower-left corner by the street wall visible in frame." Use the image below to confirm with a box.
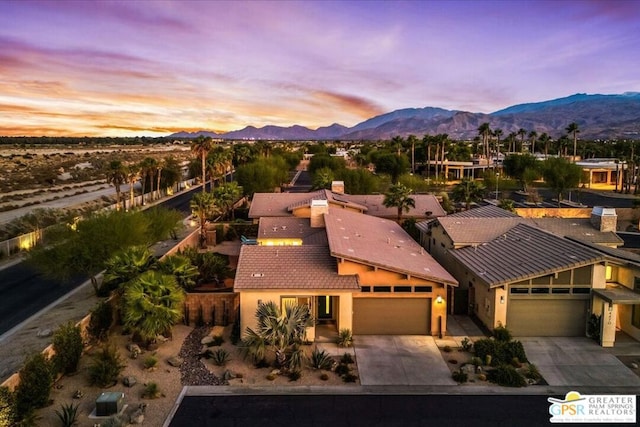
[15,353,53,419]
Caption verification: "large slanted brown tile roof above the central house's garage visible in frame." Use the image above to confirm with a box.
[324,208,458,285]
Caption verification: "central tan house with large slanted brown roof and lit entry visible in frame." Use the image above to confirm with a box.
[234,203,457,340]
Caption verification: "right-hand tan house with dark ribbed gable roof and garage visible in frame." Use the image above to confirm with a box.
[418,206,640,346]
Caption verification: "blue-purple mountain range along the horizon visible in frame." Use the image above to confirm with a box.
[170,92,640,141]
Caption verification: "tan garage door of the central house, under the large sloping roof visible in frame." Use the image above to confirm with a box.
[353,298,431,335]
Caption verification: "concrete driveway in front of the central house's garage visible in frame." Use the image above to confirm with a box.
[353,335,456,385]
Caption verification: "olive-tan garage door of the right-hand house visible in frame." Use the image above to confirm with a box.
[507,299,589,337]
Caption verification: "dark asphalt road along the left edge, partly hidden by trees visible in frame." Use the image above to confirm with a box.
[0,187,201,335]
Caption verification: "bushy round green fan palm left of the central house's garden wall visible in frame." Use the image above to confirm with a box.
[122,270,185,344]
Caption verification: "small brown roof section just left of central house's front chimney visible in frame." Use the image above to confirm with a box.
[257,216,328,246]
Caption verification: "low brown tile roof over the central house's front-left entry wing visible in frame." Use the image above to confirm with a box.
[234,245,360,291]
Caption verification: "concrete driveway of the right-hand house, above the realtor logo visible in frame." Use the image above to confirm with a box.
[517,337,640,387]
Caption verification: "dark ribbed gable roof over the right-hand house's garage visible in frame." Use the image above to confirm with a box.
[449,224,604,287]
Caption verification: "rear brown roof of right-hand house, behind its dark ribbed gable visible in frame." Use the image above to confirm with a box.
[437,219,623,245]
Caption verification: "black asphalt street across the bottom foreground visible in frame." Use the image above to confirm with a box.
[170,394,563,427]
